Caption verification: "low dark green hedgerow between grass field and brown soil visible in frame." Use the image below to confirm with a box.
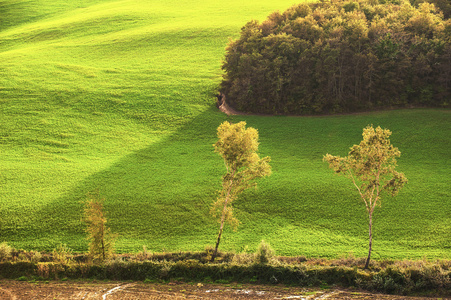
[0,252,451,295]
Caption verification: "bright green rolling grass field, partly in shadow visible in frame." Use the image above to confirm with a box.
[0,0,451,259]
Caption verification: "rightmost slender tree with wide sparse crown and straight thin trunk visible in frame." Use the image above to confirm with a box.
[324,126,407,269]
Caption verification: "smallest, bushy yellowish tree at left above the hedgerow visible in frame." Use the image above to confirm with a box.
[83,191,117,261]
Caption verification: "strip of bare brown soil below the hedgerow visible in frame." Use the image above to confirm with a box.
[0,280,443,300]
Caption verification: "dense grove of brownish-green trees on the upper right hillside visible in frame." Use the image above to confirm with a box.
[220,0,451,114]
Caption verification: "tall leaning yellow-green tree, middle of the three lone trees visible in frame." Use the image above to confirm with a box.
[211,121,271,261]
